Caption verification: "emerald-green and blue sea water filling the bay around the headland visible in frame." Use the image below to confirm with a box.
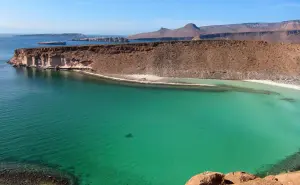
[0,35,300,185]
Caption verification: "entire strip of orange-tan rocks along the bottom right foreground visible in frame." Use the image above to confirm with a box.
[185,172,300,185]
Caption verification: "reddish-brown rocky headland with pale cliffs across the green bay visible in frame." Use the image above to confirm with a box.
[11,40,300,80]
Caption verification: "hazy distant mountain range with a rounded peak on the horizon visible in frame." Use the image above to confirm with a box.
[128,20,300,39]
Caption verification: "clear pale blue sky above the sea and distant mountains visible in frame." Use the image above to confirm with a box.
[0,0,300,35]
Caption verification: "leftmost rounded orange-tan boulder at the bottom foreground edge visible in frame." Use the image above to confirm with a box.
[185,172,225,185]
